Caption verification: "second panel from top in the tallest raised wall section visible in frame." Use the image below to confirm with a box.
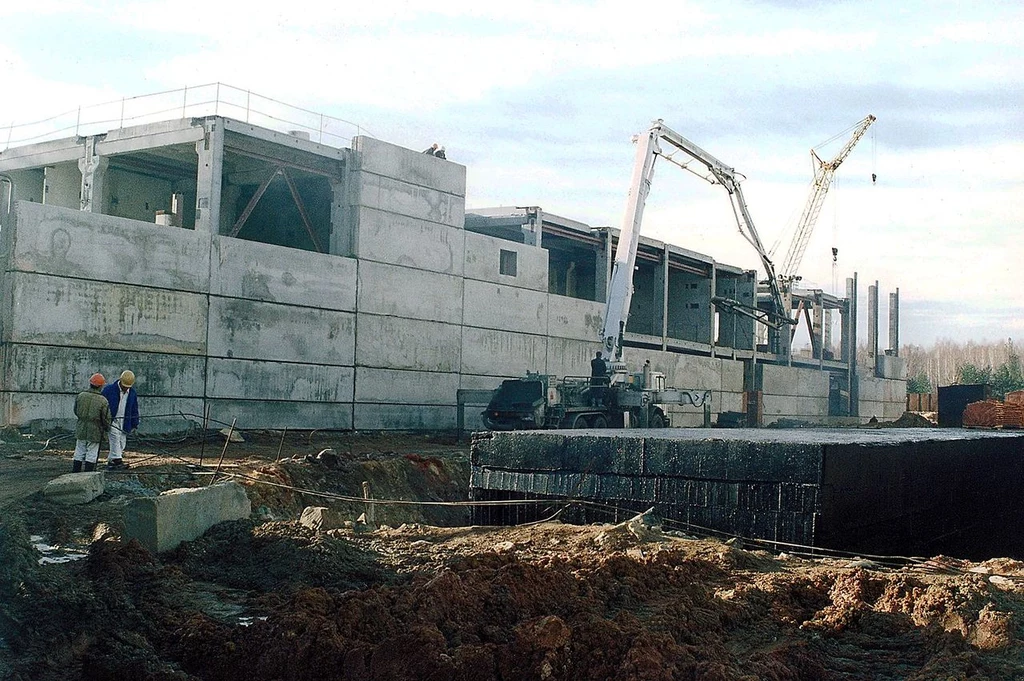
[350,172,466,227]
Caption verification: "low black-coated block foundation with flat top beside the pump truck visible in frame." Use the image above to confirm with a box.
[470,428,1024,557]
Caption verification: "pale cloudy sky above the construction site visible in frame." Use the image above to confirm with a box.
[0,0,1024,347]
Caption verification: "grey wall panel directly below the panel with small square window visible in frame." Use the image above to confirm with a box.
[463,279,548,336]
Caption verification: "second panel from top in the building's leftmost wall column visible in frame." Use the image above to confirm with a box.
[7,272,207,354]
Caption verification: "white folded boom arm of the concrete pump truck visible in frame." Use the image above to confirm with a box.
[601,119,788,359]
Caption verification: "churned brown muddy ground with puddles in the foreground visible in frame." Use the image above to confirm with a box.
[0,432,1024,681]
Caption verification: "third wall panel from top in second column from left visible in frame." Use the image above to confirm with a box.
[207,357,354,402]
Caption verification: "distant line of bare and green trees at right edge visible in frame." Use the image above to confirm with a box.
[888,339,1024,397]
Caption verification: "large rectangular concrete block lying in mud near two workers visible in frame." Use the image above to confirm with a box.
[125,482,252,553]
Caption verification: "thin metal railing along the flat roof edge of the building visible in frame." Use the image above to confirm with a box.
[0,83,375,151]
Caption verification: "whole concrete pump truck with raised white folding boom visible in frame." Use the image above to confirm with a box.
[482,119,788,430]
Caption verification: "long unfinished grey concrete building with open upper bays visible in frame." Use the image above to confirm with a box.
[0,93,905,431]
